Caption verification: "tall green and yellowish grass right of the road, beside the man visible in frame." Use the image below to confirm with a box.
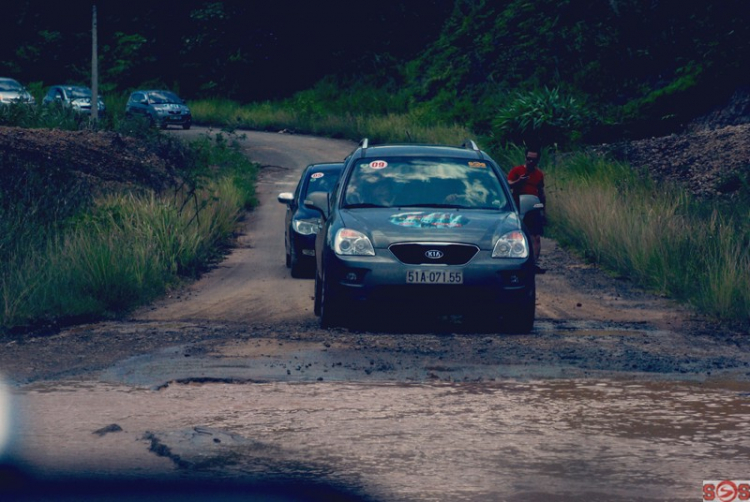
[546,153,750,320]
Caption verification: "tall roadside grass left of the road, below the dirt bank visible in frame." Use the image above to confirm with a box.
[0,135,257,332]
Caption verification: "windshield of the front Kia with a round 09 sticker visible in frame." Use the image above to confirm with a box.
[344,157,508,209]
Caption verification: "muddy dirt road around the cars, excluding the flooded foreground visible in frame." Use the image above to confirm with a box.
[0,128,750,386]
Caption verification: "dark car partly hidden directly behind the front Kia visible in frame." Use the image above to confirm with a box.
[278,162,344,277]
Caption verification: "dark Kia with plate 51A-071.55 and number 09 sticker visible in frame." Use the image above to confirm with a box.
[305,140,542,333]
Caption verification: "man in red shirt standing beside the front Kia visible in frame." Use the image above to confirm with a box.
[508,148,547,274]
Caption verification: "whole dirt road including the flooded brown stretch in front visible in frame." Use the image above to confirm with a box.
[0,128,750,501]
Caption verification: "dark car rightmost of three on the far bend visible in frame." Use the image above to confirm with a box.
[125,90,193,129]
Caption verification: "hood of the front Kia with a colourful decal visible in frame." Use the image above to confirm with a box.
[341,208,521,249]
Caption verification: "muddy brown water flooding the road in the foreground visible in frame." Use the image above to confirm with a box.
[7,380,750,501]
